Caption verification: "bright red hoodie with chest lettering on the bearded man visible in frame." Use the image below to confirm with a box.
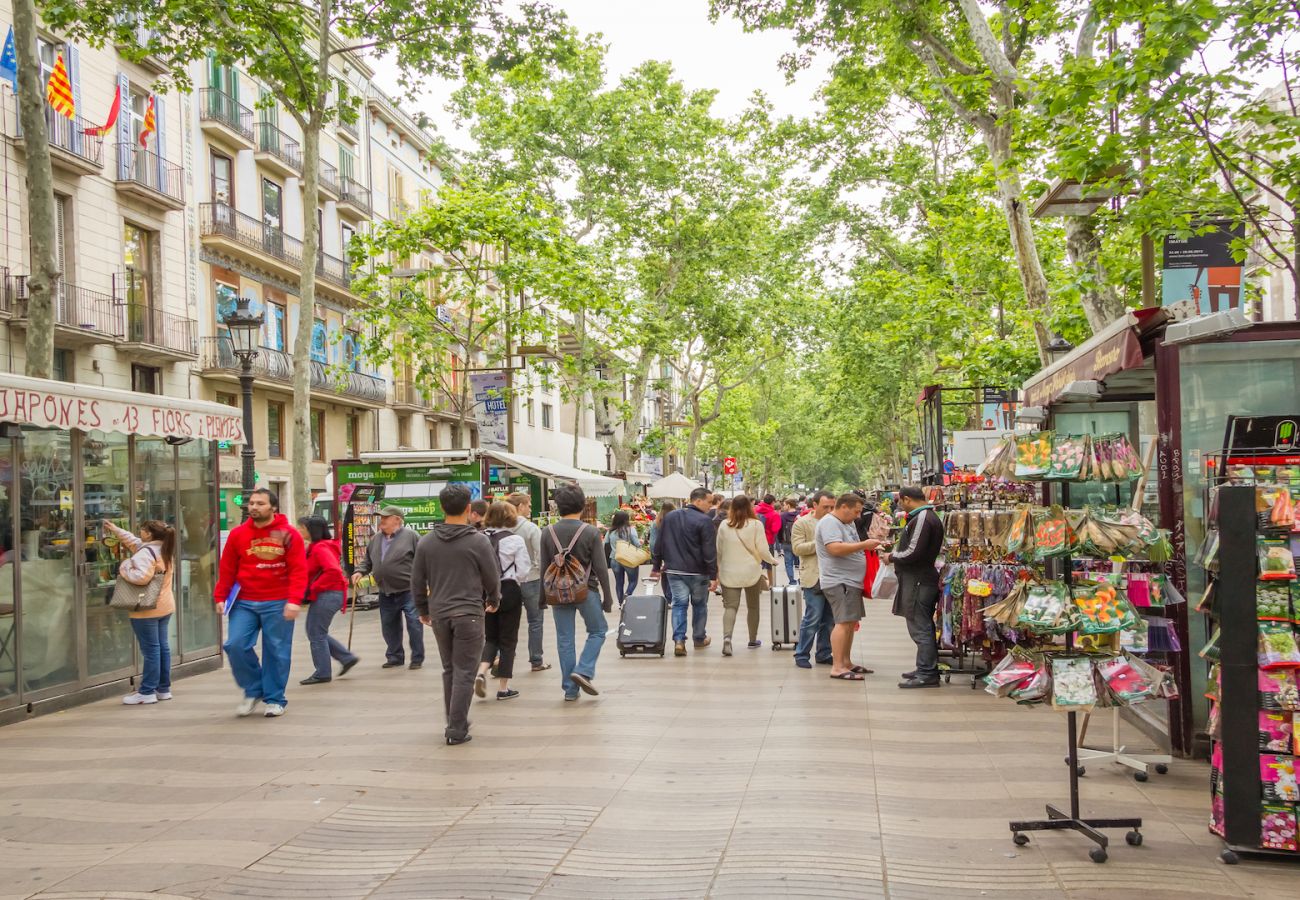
[212,512,307,606]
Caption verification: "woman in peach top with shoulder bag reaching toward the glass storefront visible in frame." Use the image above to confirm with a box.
[104,519,176,706]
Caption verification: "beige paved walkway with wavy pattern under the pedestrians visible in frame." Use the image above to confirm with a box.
[0,590,1300,900]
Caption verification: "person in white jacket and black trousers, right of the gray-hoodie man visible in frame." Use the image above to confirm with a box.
[475,501,533,700]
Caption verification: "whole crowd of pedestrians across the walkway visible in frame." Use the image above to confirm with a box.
[104,484,944,745]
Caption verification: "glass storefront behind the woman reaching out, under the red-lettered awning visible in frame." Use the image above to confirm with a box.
[0,425,220,710]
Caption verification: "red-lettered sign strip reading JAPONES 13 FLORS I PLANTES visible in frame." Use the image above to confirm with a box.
[0,386,243,443]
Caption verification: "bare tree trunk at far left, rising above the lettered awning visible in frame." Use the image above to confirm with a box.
[13,0,60,378]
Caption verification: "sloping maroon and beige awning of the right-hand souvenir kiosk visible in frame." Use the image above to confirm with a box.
[1021,307,1180,407]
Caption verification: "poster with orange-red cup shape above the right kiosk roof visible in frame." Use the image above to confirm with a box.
[1160,221,1245,315]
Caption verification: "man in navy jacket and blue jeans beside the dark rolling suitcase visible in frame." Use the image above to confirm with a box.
[650,488,718,657]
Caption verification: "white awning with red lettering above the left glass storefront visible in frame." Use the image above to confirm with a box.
[0,375,244,443]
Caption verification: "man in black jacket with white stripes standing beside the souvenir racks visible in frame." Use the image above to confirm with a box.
[884,488,944,688]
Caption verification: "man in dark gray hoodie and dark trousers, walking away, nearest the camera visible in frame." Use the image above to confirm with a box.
[411,484,501,744]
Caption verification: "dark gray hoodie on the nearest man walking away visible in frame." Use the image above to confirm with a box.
[411,523,501,620]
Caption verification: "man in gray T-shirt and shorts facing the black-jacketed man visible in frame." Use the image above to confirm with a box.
[816,494,880,682]
